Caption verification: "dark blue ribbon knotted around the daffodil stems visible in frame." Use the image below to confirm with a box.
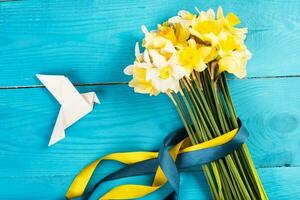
[80,121,249,200]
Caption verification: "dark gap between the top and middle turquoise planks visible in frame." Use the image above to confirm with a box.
[0,74,300,90]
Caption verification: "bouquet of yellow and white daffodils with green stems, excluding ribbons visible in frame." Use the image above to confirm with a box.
[124,8,268,200]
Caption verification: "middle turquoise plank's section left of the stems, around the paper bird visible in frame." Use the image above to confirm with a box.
[0,85,181,176]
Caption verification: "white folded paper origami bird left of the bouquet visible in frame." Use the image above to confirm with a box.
[36,74,100,146]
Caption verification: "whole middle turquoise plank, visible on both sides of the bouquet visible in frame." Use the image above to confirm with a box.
[0,78,300,176]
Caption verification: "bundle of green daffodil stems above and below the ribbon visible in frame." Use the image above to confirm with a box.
[168,68,268,200]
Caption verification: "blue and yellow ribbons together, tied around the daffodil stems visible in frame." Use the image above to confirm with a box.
[66,121,249,200]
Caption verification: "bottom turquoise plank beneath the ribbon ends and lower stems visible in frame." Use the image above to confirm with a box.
[0,167,300,200]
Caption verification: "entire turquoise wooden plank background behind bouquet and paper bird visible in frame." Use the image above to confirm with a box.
[0,0,300,200]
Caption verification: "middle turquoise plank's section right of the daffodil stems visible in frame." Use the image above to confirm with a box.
[230,78,300,167]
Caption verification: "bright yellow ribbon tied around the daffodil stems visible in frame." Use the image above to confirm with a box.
[66,129,238,200]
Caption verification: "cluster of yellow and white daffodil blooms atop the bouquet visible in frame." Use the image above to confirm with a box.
[124,7,251,95]
